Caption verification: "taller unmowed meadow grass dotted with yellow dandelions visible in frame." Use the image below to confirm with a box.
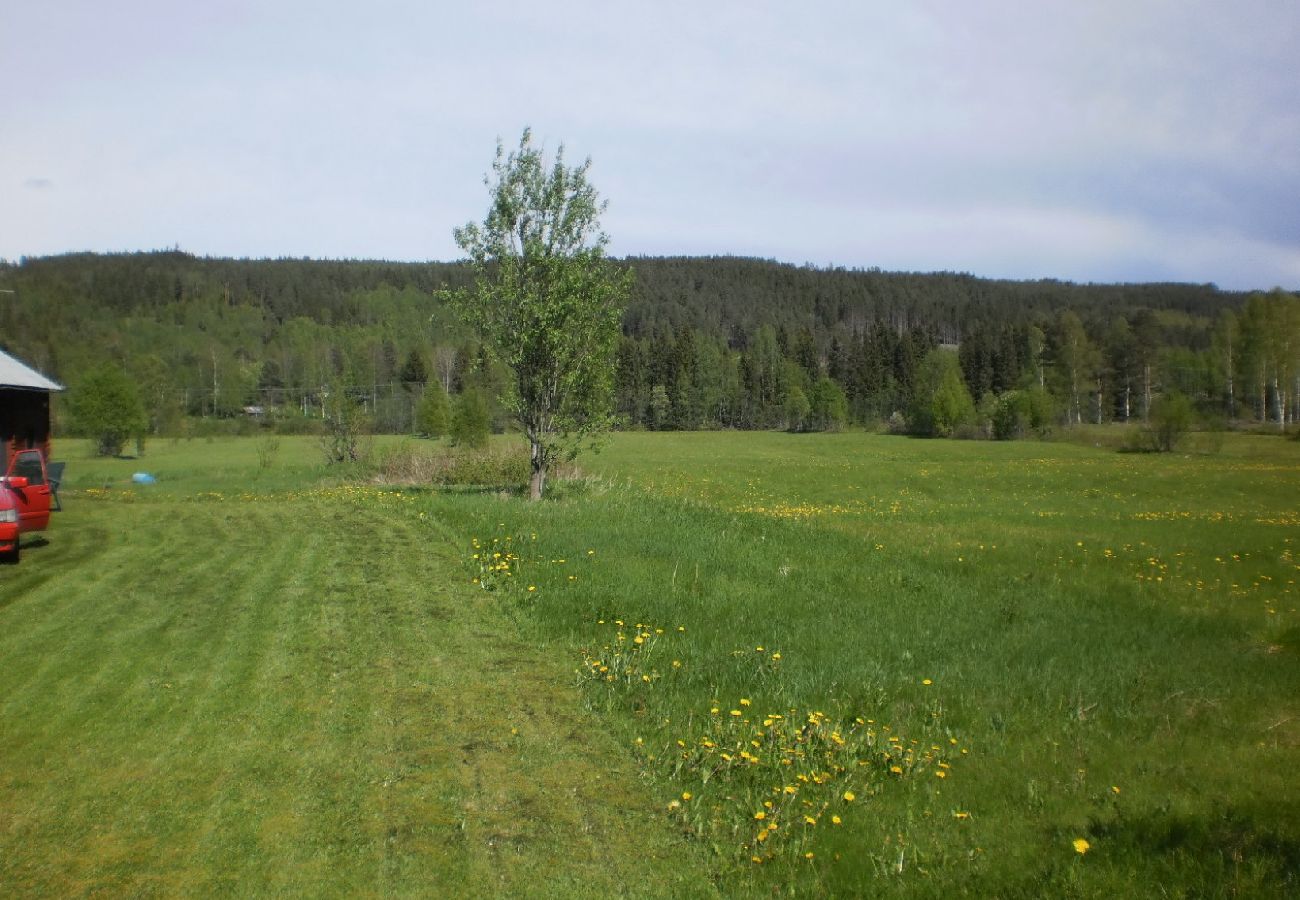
[416,434,1300,896]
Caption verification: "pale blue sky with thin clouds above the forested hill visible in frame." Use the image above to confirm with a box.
[0,0,1300,290]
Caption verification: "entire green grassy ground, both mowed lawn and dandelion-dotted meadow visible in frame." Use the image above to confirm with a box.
[0,433,1300,896]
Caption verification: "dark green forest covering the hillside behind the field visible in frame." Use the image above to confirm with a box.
[0,250,1300,437]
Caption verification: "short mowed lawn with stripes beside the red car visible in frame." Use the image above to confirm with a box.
[0,442,707,896]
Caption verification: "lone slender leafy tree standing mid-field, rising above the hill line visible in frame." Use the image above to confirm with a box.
[452,129,633,499]
